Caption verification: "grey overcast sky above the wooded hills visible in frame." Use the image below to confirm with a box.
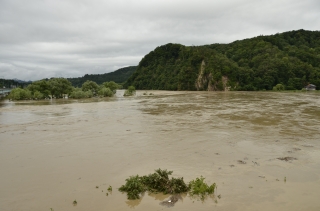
[0,0,320,80]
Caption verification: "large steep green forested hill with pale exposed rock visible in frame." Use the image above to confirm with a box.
[125,30,320,91]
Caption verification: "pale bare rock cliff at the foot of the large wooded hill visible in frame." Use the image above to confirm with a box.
[195,60,230,91]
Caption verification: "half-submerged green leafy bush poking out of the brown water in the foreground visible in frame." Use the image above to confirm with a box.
[119,169,216,200]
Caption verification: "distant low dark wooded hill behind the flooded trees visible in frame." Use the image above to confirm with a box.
[68,66,137,87]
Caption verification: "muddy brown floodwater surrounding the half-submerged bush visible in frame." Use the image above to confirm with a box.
[0,91,320,211]
